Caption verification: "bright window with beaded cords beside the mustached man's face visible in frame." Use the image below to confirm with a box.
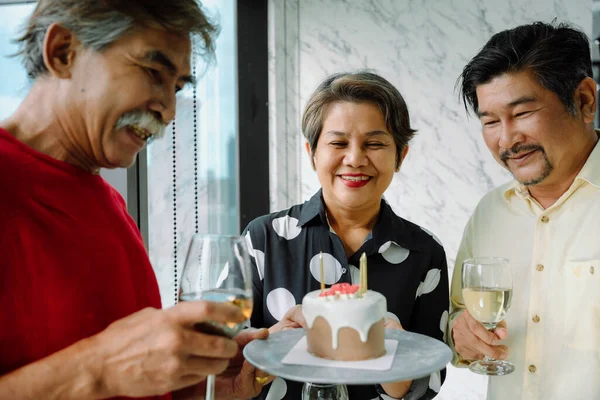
[147,0,240,303]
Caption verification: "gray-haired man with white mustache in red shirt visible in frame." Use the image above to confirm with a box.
[0,0,270,400]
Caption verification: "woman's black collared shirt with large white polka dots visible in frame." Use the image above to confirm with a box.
[243,191,449,400]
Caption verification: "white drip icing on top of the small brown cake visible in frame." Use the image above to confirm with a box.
[302,290,387,349]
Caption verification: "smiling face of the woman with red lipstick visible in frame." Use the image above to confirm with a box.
[306,102,408,210]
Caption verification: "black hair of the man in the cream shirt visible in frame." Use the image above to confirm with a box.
[457,21,593,114]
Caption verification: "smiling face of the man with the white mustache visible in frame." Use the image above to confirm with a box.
[65,24,191,168]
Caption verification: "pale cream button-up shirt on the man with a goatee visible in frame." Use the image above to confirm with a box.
[448,136,600,400]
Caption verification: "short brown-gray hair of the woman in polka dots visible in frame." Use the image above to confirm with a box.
[302,70,416,167]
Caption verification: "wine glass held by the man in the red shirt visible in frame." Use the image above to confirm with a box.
[179,235,252,400]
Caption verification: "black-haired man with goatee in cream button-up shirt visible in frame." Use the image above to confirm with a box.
[448,23,600,400]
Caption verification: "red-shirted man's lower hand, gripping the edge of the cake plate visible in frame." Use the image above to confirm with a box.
[173,328,275,400]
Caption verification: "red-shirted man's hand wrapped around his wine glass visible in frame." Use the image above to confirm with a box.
[93,301,245,397]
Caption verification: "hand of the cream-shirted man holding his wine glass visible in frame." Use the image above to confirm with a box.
[452,310,508,360]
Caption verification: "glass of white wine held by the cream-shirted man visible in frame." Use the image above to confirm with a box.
[462,257,515,376]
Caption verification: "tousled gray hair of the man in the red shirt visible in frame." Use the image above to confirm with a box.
[16,0,218,80]
